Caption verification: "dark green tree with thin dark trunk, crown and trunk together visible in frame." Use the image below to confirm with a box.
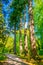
[10,0,27,53]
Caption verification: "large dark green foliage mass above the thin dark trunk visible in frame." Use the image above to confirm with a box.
[10,0,27,27]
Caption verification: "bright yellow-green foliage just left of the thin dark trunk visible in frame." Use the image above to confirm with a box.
[5,36,14,53]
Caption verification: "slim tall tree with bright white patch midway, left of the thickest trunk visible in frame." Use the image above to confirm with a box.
[24,9,28,55]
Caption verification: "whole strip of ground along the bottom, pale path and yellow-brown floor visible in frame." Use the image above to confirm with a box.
[0,54,43,65]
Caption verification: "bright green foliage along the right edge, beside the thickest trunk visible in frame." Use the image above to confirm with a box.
[33,0,43,49]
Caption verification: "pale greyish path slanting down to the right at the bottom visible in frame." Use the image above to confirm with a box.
[5,54,29,65]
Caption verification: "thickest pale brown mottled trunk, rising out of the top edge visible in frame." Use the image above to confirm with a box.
[28,0,37,58]
